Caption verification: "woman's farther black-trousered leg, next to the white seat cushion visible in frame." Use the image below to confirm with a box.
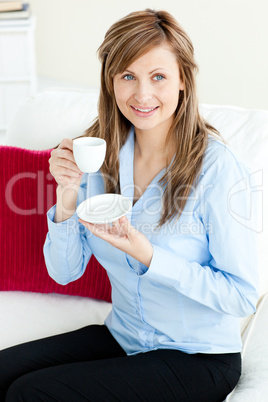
[0,325,126,401]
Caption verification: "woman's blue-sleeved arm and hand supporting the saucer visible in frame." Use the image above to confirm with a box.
[83,159,258,317]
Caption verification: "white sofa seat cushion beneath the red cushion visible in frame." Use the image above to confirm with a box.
[0,292,112,350]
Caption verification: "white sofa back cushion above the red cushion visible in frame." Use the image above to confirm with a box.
[5,88,99,150]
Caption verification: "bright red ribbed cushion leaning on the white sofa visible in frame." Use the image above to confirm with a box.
[0,146,111,301]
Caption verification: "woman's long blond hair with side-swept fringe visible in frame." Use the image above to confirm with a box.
[85,9,218,226]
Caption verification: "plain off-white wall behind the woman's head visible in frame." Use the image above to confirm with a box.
[31,0,268,109]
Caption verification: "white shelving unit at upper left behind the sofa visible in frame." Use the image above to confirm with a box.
[0,17,37,137]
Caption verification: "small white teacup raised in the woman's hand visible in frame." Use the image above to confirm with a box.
[73,137,106,173]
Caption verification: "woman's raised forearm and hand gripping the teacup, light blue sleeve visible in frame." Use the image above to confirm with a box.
[44,139,92,285]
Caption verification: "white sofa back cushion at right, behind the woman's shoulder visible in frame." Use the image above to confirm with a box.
[200,104,268,295]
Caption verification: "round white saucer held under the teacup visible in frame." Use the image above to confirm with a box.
[76,194,132,223]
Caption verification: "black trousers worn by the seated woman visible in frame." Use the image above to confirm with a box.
[0,325,241,402]
